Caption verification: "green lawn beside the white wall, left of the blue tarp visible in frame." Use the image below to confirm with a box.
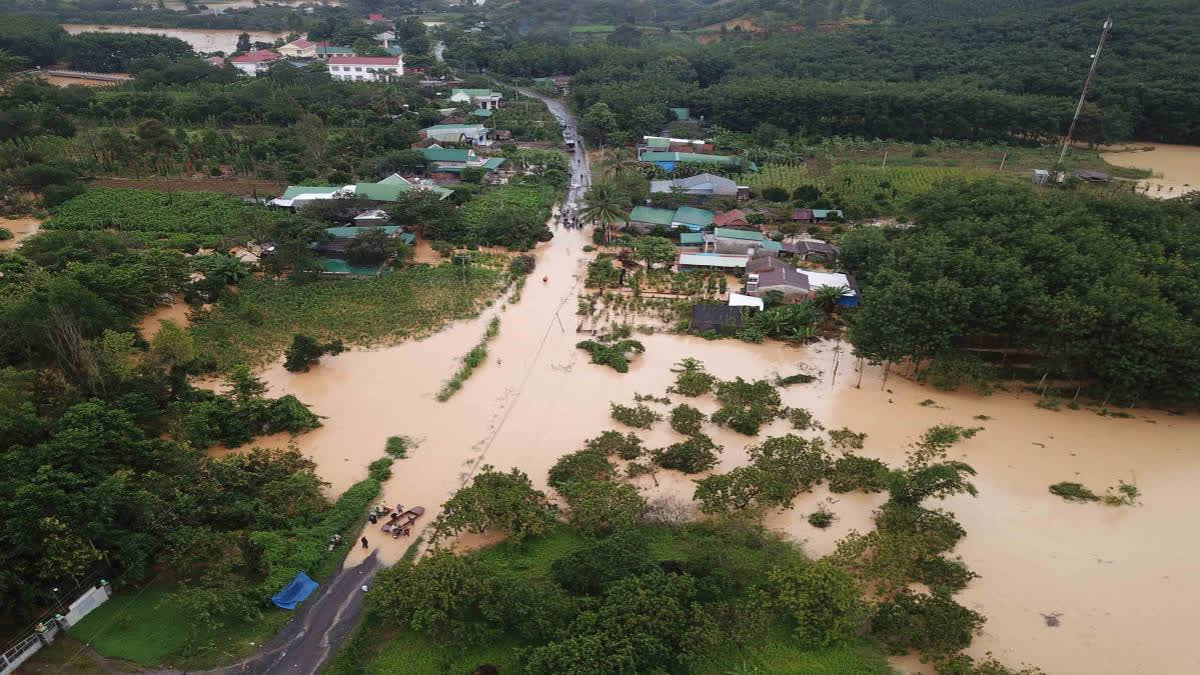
[70,584,292,669]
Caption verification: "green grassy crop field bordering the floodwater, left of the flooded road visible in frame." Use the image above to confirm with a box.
[192,260,504,370]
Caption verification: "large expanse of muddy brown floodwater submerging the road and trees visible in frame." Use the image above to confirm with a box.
[211,216,1200,674]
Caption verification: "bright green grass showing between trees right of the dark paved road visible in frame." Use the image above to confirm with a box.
[328,526,893,675]
